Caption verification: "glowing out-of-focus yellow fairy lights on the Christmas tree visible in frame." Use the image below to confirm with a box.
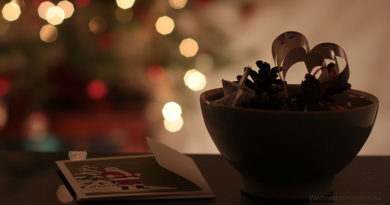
[2,0,212,132]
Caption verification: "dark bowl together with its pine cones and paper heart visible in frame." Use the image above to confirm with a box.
[200,32,379,199]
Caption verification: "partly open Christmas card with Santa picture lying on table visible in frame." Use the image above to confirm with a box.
[56,138,213,201]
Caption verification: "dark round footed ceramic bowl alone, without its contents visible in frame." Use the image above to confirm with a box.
[200,88,379,199]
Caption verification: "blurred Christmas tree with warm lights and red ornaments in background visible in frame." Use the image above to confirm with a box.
[0,0,233,151]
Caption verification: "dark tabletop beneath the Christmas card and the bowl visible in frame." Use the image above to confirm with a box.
[0,151,390,205]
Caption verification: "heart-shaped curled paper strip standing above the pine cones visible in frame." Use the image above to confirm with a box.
[272,31,349,89]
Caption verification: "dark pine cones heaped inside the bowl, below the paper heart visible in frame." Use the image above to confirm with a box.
[237,61,351,111]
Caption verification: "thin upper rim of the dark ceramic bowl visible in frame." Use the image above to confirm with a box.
[200,87,379,115]
